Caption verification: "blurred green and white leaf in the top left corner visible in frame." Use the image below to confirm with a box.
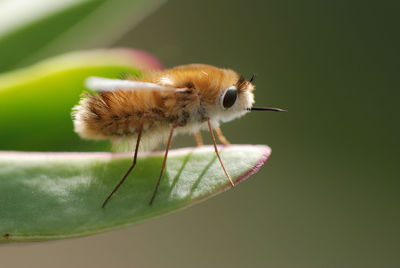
[0,0,165,72]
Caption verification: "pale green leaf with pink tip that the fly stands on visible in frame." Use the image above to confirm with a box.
[0,145,270,242]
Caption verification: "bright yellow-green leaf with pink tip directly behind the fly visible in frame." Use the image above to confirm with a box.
[0,49,162,151]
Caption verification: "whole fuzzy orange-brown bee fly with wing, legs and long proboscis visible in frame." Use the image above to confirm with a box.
[73,64,284,208]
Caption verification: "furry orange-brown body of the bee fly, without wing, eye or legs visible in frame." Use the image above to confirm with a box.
[73,64,254,149]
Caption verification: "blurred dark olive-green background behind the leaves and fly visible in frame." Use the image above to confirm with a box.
[0,0,400,267]
